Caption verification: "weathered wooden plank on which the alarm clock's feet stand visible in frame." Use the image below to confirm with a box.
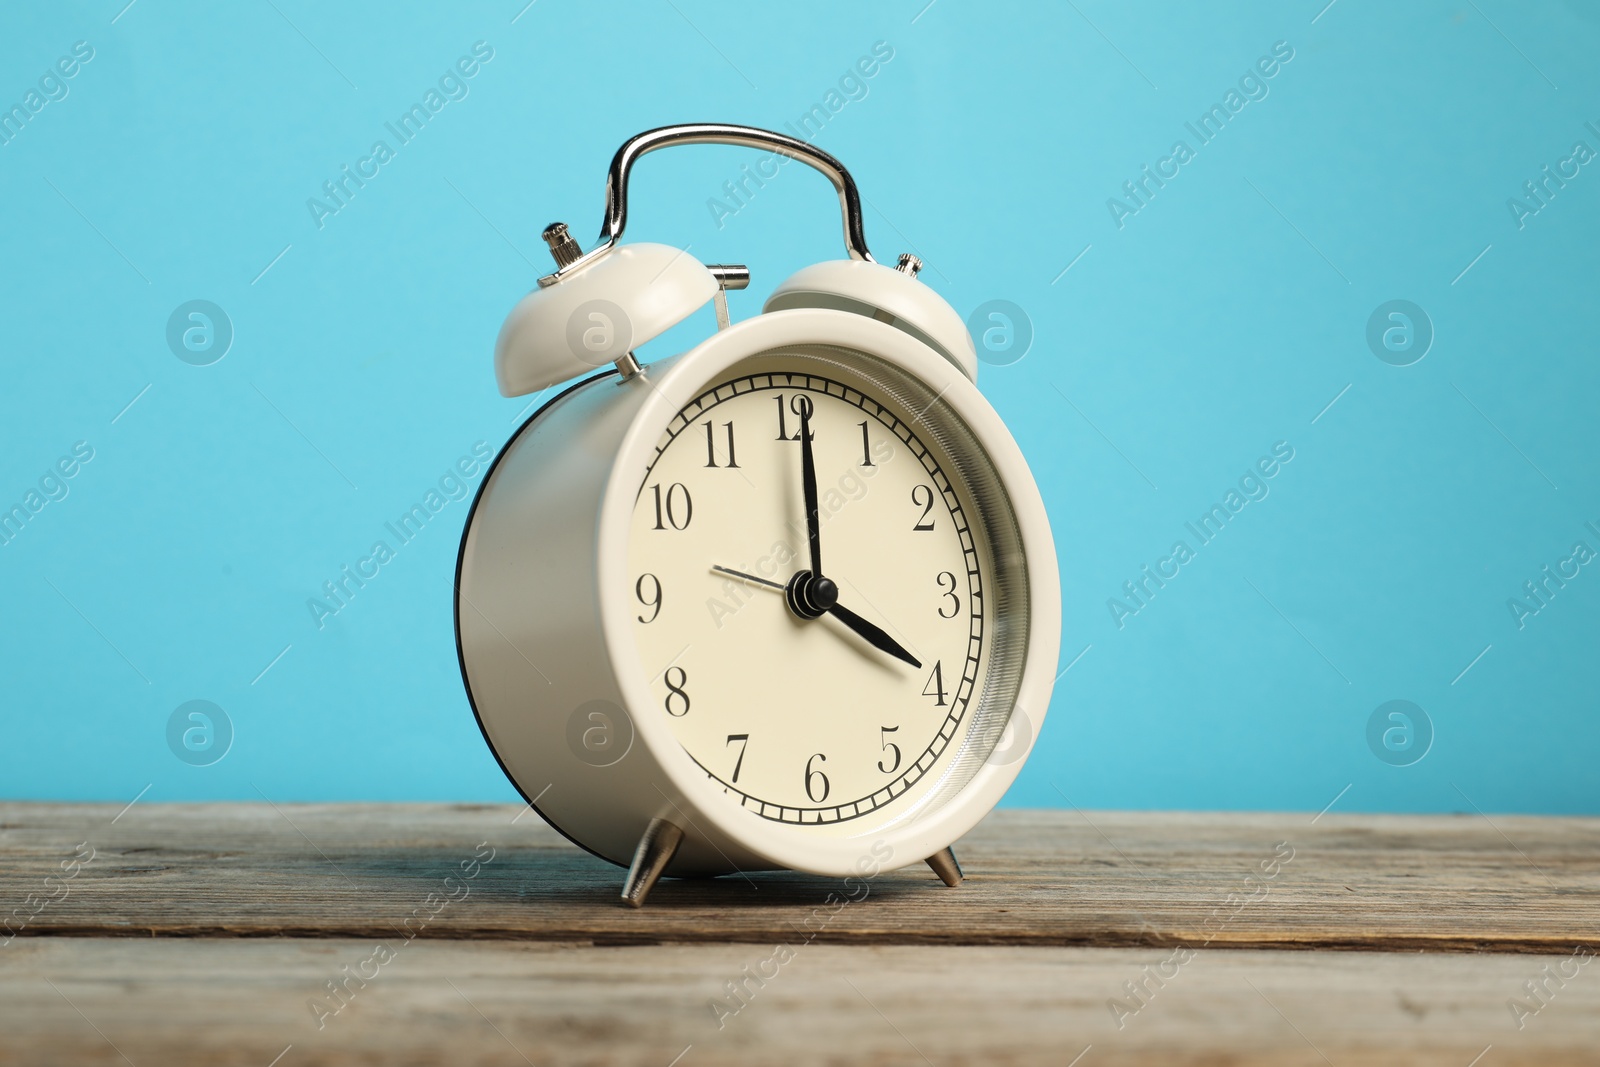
[0,803,1600,953]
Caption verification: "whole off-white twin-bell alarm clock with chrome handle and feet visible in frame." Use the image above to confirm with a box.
[454,123,1061,907]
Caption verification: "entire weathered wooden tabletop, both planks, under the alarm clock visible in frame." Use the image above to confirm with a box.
[0,803,1600,1067]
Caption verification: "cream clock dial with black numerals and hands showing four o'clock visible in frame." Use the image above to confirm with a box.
[627,354,1026,835]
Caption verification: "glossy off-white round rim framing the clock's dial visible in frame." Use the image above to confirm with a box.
[597,307,1061,877]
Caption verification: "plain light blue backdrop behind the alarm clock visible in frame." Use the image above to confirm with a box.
[0,0,1600,813]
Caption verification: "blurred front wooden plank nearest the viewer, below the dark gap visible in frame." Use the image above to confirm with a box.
[0,937,1600,1067]
